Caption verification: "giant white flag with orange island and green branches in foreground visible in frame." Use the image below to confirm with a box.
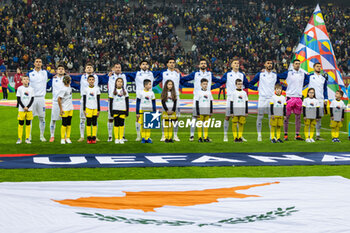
[0,176,350,233]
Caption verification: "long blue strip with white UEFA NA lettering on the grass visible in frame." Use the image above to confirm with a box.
[0,152,350,168]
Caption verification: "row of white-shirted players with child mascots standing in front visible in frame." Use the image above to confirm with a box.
[9,58,346,144]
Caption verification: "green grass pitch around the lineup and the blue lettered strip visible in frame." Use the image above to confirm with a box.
[0,93,350,182]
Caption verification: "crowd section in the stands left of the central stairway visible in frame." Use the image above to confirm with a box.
[0,0,184,72]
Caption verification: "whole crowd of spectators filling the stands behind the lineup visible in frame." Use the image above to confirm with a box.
[0,0,350,73]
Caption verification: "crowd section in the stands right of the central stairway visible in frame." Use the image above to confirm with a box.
[183,1,350,73]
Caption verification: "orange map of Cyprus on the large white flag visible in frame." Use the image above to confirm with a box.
[54,182,279,212]
